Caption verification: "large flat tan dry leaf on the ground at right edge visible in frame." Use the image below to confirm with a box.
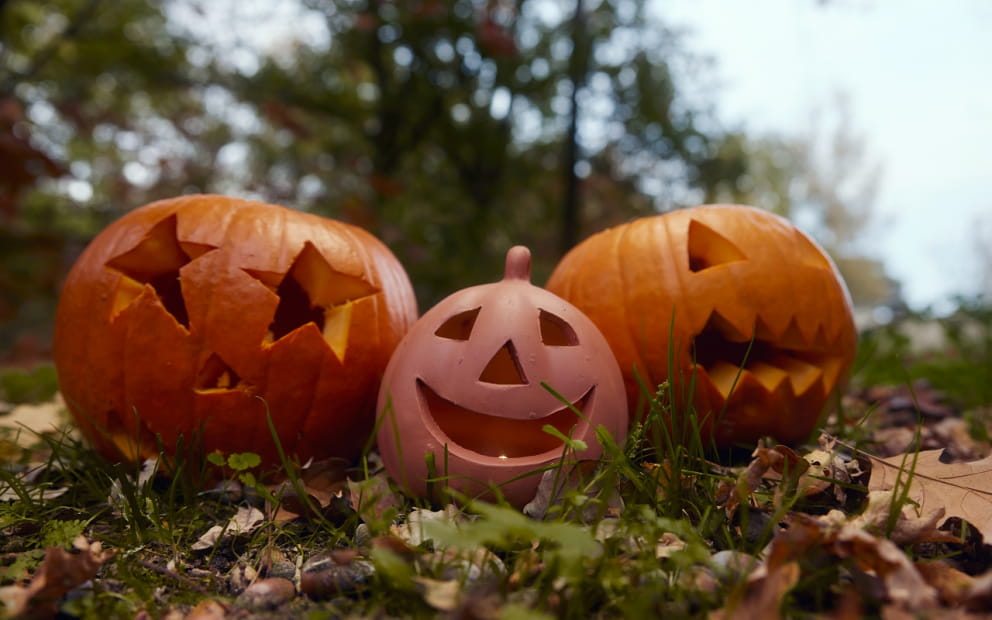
[868,450,992,541]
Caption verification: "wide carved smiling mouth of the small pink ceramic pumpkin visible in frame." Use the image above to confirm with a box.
[417,379,595,458]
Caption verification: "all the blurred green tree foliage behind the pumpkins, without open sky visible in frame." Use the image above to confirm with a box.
[0,0,894,357]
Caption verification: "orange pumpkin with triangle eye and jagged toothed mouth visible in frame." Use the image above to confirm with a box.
[547,205,857,446]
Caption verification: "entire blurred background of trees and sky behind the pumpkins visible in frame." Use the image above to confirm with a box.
[0,0,992,365]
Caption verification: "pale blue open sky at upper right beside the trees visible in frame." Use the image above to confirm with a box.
[652,0,992,312]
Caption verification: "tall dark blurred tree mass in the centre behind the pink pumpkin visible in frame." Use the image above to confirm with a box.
[184,0,743,303]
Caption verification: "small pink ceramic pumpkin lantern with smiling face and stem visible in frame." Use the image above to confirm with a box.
[378,246,628,506]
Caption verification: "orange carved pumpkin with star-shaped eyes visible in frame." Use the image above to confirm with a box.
[54,195,417,463]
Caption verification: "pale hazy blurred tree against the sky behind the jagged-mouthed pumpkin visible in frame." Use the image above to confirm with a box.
[706,97,902,308]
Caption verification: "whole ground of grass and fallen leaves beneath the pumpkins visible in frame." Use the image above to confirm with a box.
[0,312,992,620]
